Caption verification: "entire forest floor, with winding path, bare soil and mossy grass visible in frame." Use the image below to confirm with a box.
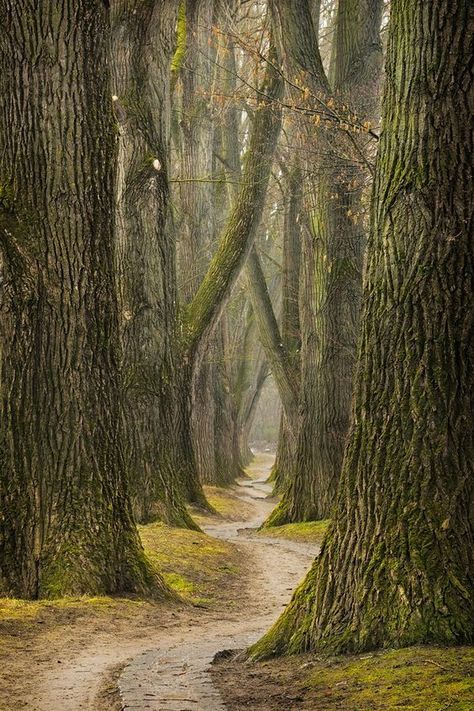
[0,455,474,711]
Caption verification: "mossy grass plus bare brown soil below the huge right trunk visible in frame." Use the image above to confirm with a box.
[214,647,474,711]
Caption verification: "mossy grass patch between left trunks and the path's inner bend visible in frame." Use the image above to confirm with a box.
[139,523,238,605]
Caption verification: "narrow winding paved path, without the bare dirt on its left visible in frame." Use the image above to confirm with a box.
[119,479,317,711]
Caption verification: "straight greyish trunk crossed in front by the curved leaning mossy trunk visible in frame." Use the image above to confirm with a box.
[176,0,248,485]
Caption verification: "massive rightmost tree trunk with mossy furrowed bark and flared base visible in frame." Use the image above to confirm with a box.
[250,0,474,658]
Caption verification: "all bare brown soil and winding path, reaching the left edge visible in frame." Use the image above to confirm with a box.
[0,458,318,711]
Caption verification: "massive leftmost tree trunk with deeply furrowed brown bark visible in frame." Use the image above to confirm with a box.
[0,0,165,598]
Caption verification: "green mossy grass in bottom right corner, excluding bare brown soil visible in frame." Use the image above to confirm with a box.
[303,647,474,711]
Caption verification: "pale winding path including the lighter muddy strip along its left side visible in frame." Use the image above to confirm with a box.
[13,462,318,711]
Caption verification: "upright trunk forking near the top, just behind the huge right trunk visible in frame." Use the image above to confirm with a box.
[268,0,382,525]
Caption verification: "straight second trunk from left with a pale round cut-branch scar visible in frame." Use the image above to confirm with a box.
[111,0,194,527]
